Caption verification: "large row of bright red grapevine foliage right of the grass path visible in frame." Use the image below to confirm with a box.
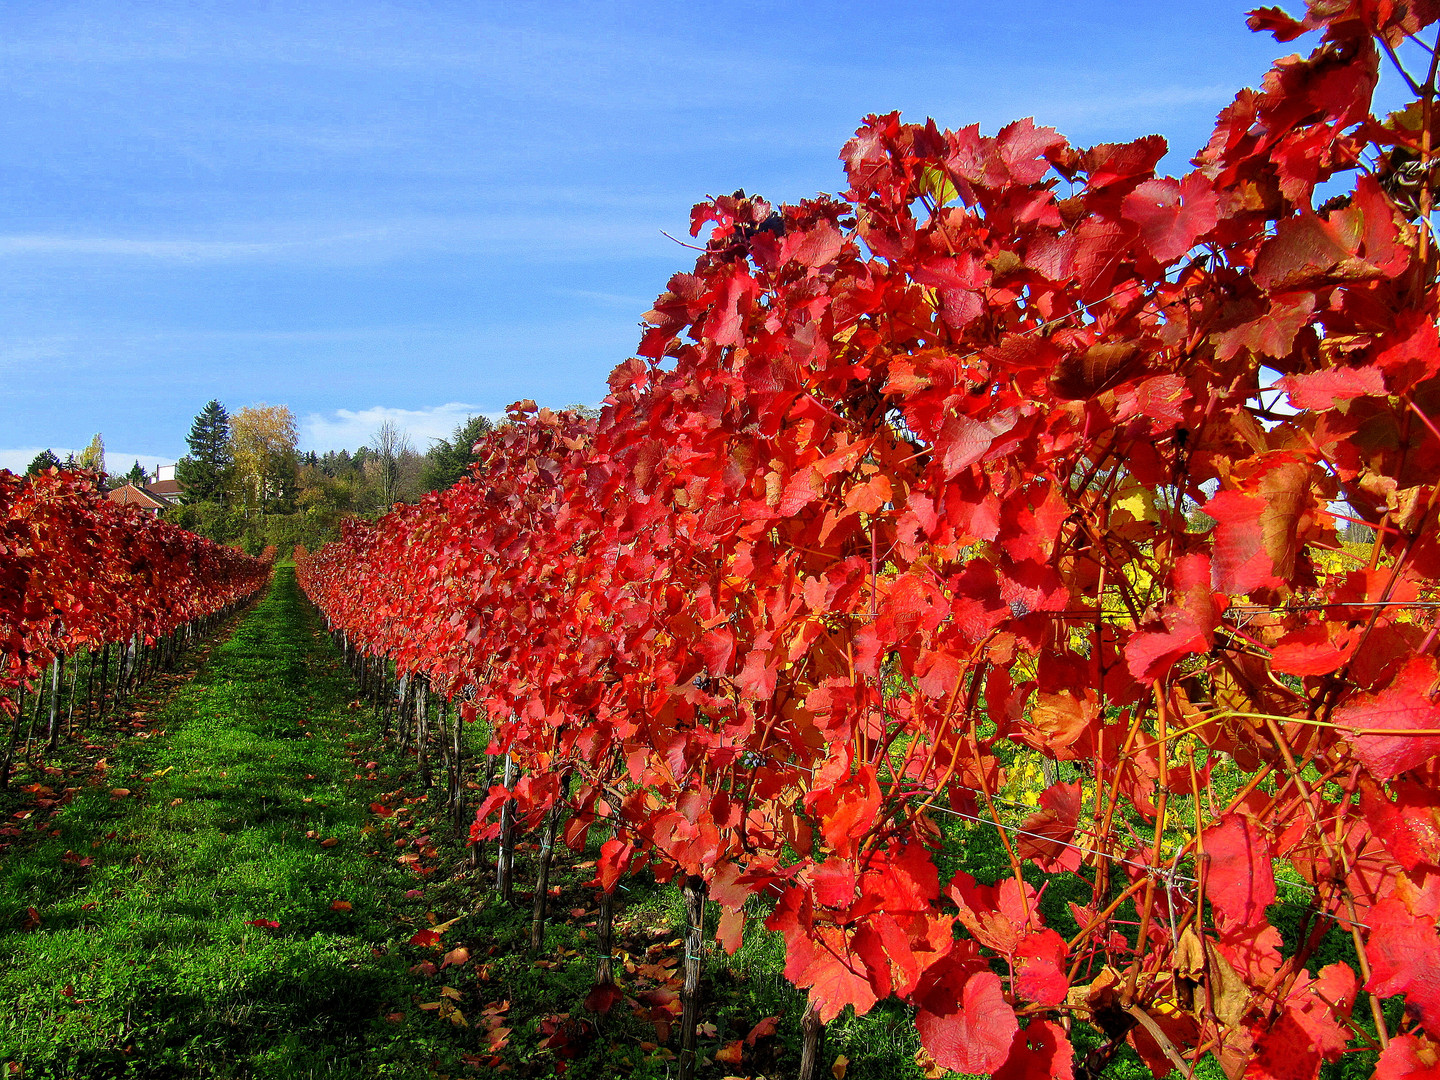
[302,0,1440,1077]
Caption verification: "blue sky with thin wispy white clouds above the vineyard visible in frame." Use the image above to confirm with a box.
[0,0,1416,469]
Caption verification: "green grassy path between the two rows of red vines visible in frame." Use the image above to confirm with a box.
[0,567,448,1080]
